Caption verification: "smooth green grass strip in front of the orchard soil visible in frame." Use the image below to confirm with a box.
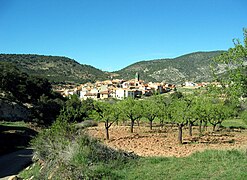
[115,150,247,180]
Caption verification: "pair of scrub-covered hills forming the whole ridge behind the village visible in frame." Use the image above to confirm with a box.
[0,50,225,83]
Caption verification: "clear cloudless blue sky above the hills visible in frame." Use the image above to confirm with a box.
[0,0,247,71]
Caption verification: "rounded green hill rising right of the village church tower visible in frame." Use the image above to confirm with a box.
[113,51,224,84]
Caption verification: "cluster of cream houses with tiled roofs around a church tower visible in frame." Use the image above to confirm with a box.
[55,73,176,100]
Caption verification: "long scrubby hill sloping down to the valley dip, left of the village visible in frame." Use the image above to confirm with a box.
[0,54,109,83]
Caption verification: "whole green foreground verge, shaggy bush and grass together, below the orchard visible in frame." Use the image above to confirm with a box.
[20,116,247,179]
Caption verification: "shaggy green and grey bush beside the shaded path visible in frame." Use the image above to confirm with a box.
[32,116,138,179]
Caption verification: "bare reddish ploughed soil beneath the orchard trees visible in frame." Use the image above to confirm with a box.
[88,124,247,157]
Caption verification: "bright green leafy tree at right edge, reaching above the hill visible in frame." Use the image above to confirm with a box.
[214,28,247,99]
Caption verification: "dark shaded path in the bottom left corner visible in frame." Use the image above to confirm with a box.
[0,148,33,180]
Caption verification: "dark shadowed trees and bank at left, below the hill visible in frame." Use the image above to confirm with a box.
[0,62,65,125]
